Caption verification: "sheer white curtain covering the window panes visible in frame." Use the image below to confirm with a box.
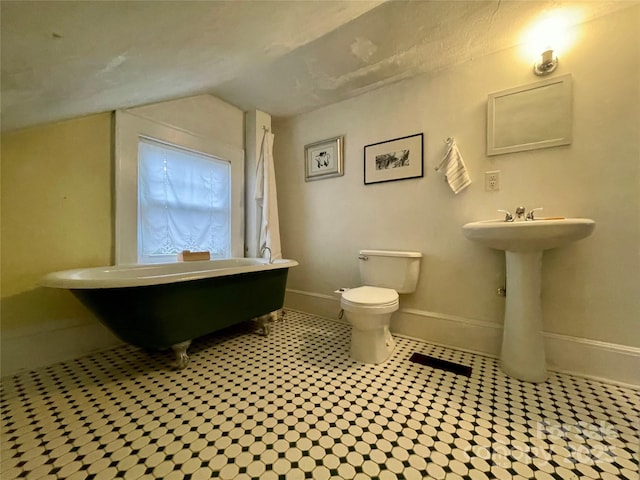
[138,138,231,262]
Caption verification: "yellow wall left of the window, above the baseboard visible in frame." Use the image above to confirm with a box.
[0,113,113,335]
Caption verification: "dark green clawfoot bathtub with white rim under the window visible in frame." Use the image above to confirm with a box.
[40,258,298,368]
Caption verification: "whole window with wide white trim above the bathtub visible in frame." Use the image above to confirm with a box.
[116,112,244,264]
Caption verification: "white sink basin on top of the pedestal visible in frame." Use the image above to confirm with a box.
[462,218,596,252]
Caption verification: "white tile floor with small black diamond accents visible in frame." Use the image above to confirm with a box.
[1,312,639,480]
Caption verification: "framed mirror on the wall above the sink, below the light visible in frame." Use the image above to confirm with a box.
[487,74,572,156]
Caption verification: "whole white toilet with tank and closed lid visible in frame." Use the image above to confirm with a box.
[340,250,422,363]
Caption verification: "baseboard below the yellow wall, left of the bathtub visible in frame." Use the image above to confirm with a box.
[0,322,123,377]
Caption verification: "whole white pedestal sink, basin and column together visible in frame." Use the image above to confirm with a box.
[462,218,596,382]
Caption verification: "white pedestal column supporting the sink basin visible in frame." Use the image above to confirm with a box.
[500,250,547,382]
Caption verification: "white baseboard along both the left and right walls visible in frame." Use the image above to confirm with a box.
[0,289,640,387]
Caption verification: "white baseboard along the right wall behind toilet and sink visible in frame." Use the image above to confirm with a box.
[285,289,640,388]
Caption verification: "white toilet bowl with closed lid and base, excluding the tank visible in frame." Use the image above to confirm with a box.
[340,286,399,364]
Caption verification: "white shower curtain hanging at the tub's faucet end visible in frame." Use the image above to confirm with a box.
[255,129,282,260]
